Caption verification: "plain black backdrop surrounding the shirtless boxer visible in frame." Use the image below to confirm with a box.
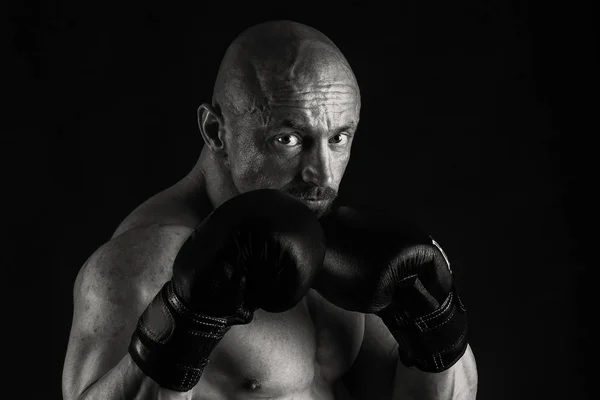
[7,1,598,400]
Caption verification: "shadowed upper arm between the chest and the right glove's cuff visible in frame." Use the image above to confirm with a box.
[343,314,398,400]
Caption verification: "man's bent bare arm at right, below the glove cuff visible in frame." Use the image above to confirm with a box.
[343,314,478,400]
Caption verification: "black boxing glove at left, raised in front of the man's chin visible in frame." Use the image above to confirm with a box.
[129,189,325,392]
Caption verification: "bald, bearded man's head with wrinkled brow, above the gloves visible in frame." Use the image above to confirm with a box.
[198,21,360,215]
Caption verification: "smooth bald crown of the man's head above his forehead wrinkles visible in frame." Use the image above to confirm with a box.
[213,21,360,118]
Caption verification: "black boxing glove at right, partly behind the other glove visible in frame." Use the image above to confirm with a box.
[315,207,468,372]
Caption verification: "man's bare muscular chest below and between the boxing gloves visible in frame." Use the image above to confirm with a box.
[194,291,364,400]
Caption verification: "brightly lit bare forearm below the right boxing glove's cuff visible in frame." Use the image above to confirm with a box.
[392,346,478,400]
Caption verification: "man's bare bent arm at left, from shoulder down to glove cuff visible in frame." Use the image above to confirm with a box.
[63,227,191,400]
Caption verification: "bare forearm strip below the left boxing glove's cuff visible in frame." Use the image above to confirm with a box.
[76,354,192,400]
